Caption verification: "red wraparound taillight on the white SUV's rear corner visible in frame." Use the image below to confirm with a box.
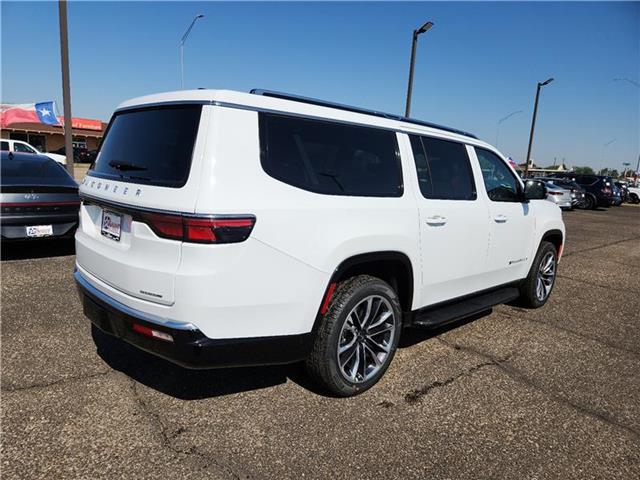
[134,213,256,243]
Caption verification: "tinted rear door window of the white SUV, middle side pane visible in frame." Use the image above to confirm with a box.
[411,135,477,200]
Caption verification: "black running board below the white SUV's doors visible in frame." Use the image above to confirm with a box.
[412,287,520,328]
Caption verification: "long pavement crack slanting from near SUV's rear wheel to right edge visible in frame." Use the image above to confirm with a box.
[438,337,640,441]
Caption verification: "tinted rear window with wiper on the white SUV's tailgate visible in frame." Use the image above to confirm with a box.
[89,105,202,188]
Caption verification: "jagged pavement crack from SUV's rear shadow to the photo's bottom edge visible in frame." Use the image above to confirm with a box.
[131,380,249,480]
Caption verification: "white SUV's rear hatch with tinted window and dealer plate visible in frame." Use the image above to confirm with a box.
[76,104,206,305]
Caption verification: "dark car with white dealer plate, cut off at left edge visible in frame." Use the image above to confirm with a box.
[0,152,80,242]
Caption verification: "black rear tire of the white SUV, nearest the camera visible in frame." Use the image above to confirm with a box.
[305,275,402,397]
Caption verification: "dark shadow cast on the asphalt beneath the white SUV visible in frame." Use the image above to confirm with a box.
[91,310,491,400]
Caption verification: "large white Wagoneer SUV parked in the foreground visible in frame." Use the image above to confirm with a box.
[75,90,565,396]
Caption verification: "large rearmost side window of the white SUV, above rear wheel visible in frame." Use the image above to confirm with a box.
[259,113,403,197]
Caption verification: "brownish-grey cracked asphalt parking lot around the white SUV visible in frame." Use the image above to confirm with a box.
[2,205,640,479]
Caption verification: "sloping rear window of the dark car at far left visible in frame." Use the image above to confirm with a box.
[0,155,76,186]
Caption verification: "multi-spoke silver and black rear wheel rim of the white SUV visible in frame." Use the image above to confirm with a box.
[337,295,397,383]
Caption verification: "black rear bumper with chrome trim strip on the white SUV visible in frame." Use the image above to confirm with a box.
[74,271,312,368]
